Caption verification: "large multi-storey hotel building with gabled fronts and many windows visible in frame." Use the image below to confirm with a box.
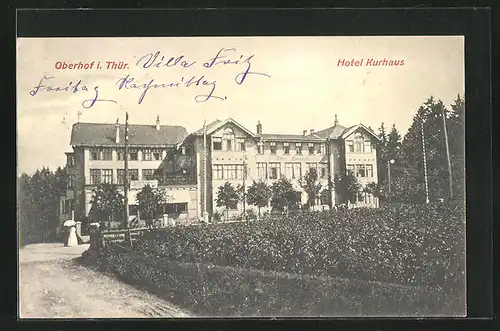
[60,116,378,228]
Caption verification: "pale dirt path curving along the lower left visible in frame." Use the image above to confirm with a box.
[19,244,188,318]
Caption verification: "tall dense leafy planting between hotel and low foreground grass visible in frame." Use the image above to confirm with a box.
[135,204,465,293]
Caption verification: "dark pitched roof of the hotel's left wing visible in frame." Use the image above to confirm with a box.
[70,123,188,146]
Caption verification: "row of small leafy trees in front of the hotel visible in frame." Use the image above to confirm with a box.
[90,169,361,228]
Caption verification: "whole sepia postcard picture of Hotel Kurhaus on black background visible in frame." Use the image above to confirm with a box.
[16,35,467,319]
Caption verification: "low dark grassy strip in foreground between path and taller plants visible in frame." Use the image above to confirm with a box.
[102,249,464,317]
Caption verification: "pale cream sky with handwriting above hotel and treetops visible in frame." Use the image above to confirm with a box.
[17,36,464,173]
